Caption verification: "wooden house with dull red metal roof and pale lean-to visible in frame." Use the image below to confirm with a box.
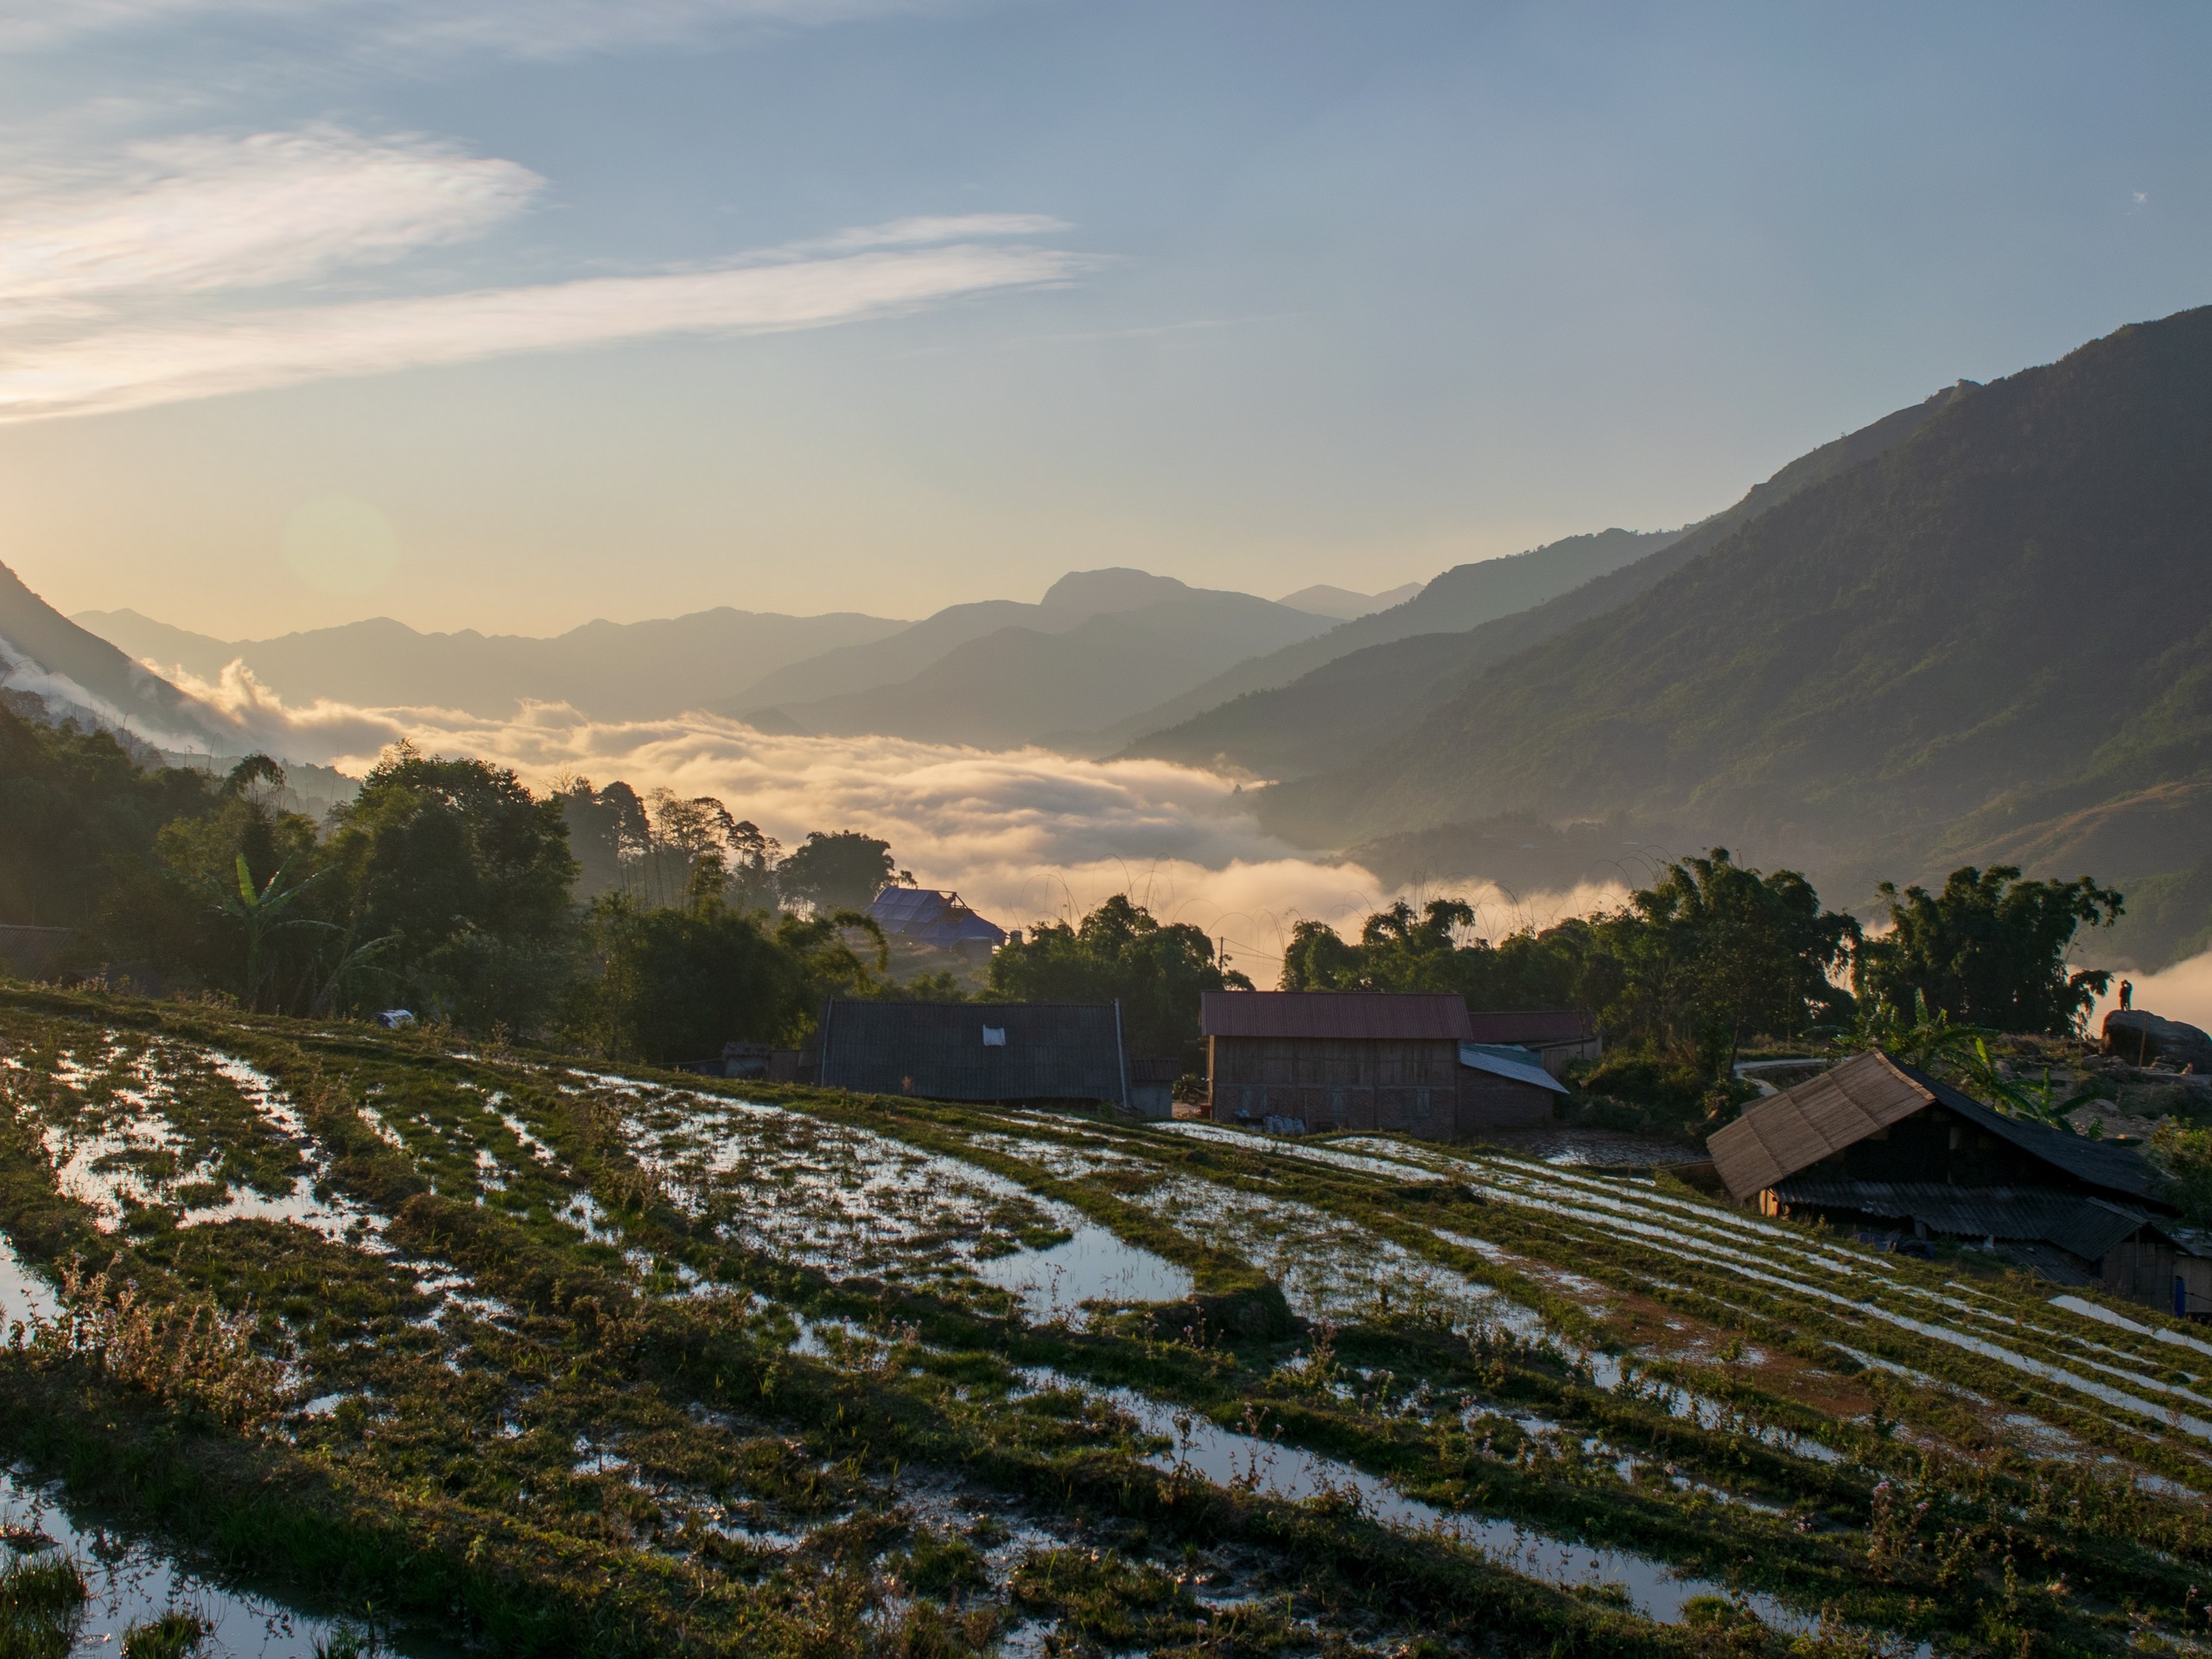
[1199,991,1566,1141]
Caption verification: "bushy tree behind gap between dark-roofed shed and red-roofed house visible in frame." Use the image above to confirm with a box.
[991,893,1252,1064]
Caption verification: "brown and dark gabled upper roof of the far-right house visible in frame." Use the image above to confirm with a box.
[1706,1048,2165,1208]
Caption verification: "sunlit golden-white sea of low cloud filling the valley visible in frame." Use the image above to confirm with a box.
[179,666,1624,984]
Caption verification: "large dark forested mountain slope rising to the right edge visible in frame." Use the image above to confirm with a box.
[1261,308,2212,973]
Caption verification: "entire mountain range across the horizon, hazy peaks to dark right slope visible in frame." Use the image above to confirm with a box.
[26,309,2212,967]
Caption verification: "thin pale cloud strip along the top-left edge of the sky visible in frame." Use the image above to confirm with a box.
[0,0,947,58]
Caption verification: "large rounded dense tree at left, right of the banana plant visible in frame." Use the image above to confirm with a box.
[325,743,577,1031]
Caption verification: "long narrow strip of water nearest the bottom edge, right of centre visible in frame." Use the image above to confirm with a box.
[1022,1370,1818,1635]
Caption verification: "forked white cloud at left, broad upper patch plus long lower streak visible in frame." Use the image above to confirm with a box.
[0,128,1079,420]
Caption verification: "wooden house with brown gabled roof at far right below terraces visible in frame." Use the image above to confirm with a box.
[1707,1051,2212,1316]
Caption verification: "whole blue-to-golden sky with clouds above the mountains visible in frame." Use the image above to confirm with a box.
[0,0,2212,637]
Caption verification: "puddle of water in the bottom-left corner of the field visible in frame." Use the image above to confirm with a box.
[0,1471,353,1659]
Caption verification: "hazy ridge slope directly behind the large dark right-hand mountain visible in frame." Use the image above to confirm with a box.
[1128,390,1958,779]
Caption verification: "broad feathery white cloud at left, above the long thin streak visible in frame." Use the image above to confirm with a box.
[0,126,544,319]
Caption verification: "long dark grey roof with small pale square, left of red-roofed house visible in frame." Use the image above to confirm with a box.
[821,998,1128,1103]
